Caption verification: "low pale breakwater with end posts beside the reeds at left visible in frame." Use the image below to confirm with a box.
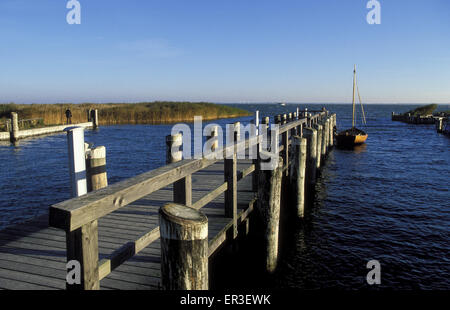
[0,110,98,143]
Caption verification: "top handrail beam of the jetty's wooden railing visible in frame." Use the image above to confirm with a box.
[49,115,316,231]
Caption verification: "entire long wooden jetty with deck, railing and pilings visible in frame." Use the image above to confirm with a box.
[0,110,336,289]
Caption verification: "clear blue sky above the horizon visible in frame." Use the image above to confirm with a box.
[0,0,450,103]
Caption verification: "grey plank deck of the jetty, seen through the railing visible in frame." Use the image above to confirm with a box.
[0,160,254,290]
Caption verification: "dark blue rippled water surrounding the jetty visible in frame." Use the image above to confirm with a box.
[0,105,450,289]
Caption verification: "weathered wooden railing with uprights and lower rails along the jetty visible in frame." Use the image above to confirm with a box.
[49,111,328,289]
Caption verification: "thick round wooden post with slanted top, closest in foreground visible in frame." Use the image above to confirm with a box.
[159,203,209,290]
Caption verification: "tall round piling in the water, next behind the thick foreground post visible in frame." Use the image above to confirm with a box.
[257,157,283,273]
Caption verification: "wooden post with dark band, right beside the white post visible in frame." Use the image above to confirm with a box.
[86,146,108,192]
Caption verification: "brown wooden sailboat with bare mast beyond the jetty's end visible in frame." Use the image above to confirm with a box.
[336,65,368,147]
